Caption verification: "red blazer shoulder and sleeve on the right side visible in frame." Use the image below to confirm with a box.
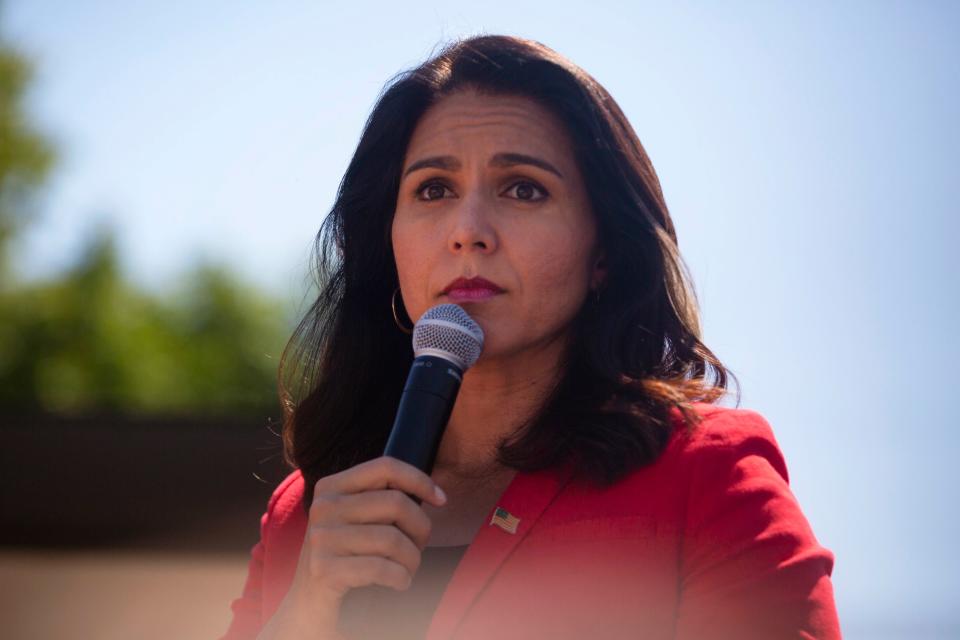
[668,406,840,638]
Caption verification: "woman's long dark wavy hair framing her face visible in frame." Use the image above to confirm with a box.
[279,35,728,508]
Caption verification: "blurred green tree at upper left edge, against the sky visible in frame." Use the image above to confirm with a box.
[0,34,55,287]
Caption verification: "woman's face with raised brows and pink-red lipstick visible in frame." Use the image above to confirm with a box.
[392,92,603,360]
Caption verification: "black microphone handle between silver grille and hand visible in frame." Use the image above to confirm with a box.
[383,356,462,504]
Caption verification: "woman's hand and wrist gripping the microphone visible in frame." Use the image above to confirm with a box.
[258,456,446,639]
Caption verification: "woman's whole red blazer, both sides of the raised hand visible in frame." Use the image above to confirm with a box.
[223,405,840,640]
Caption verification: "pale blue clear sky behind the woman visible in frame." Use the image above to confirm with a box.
[0,0,960,639]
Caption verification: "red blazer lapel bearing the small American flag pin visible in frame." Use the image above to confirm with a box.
[426,465,573,640]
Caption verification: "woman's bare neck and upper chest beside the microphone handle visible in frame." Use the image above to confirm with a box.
[434,341,564,484]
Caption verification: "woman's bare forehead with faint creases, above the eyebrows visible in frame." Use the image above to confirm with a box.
[404,91,573,166]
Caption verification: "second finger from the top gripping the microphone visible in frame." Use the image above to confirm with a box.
[310,489,433,549]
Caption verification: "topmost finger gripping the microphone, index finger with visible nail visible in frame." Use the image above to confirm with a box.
[315,456,446,507]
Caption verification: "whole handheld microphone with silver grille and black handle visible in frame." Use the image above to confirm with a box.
[383,304,483,496]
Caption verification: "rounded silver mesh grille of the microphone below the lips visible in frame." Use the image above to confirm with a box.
[413,303,483,371]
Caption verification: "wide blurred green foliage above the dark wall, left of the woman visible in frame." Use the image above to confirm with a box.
[0,224,291,415]
